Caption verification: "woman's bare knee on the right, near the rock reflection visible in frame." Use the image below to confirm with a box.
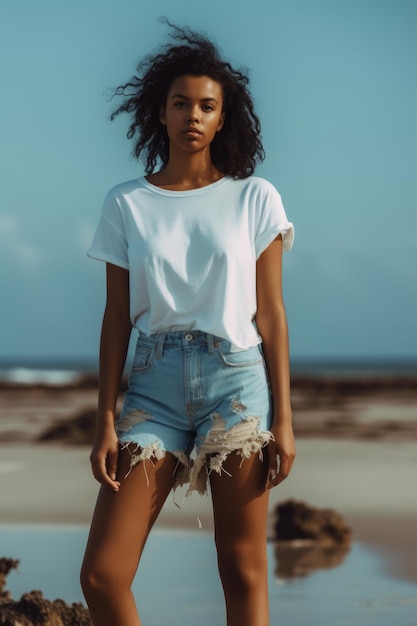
[217,542,268,593]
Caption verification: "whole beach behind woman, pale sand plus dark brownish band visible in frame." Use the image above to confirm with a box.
[0,377,417,626]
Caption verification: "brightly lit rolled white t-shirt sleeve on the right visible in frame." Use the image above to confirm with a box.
[255,180,294,259]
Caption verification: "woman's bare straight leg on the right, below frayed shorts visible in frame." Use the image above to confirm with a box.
[210,453,269,626]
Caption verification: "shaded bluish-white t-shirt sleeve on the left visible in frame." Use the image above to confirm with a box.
[87,191,129,270]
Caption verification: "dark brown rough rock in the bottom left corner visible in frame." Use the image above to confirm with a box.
[0,558,91,626]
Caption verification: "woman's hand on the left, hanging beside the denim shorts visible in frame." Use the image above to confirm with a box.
[90,428,120,491]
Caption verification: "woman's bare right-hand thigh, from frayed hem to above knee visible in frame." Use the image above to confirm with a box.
[210,453,269,545]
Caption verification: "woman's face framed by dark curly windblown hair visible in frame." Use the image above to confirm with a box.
[160,75,224,152]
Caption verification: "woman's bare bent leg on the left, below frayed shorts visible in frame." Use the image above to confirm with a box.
[81,450,177,626]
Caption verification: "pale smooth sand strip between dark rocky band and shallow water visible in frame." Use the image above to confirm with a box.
[0,438,417,582]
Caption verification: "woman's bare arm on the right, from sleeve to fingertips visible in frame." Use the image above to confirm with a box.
[256,235,295,488]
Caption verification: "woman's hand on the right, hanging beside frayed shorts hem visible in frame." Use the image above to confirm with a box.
[266,423,295,489]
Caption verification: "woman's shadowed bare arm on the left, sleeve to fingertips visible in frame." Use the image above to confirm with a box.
[90,263,132,491]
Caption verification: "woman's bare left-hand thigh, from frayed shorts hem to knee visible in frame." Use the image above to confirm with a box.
[84,450,177,584]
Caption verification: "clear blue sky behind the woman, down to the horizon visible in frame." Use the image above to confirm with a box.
[0,0,417,363]
